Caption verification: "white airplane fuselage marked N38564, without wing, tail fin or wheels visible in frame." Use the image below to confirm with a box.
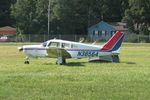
[22,39,112,58]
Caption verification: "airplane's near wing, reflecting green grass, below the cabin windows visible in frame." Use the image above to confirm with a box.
[46,47,71,58]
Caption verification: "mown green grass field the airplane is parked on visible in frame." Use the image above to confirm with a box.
[0,43,150,100]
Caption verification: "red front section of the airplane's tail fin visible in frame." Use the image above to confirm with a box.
[101,31,123,50]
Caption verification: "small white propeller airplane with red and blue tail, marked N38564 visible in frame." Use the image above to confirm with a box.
[18,31,124,65]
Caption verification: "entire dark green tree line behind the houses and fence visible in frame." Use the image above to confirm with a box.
[0,0,150,34]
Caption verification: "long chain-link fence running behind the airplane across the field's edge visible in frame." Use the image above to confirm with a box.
[1,34,150,43]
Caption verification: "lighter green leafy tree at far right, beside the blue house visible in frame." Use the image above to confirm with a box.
[123,0,150,34]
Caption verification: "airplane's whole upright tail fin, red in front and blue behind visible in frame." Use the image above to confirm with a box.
[101,31,124,51]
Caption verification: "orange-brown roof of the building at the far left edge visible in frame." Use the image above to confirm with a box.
[0,26,17,35]
